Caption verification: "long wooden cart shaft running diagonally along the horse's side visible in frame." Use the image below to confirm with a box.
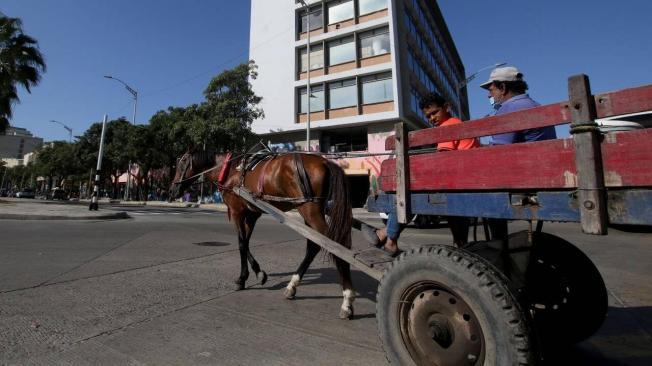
[233,187,383,281]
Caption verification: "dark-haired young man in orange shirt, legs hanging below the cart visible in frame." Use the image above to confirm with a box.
[362,93,480,255]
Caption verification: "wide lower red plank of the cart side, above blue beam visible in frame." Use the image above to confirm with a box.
[380,129,652,193]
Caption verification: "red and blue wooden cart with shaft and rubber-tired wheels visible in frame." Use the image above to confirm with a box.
[235,75,652,366]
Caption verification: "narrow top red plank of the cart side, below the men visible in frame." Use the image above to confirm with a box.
[385,85,652,150]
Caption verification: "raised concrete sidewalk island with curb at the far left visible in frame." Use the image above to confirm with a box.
[0,198,129,220]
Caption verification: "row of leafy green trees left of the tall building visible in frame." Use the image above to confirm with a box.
[19,62,263,197]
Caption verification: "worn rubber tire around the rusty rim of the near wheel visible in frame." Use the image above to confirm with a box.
[376,245,538,366]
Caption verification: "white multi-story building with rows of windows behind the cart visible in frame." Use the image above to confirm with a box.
[250,0,469,204]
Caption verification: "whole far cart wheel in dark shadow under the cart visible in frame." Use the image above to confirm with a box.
[524,233,608,347]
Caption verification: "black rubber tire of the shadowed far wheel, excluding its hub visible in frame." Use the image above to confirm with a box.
[524,233,609,349]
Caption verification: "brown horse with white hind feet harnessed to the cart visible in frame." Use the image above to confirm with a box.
[170,152,355,319]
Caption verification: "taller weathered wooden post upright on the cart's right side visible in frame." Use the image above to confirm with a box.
[568,75,608,235]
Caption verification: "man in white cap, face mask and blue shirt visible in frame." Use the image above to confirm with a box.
[480,66,557,145]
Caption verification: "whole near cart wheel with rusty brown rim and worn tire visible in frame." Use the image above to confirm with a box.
[376,245,536,366]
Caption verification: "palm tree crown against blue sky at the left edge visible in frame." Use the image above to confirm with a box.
[0,13,45,133]
